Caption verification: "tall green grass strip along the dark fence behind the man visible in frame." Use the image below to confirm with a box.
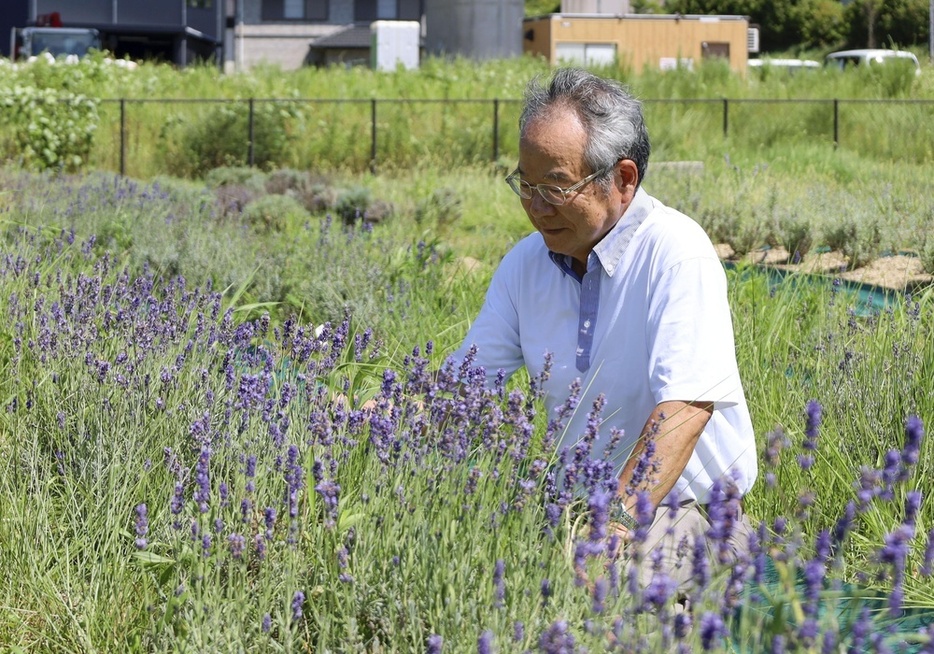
[0,57,934,178]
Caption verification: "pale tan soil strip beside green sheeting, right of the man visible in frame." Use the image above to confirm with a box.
[716,244,934,291]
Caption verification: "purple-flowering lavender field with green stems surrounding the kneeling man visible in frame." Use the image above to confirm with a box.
[0,170,934,652]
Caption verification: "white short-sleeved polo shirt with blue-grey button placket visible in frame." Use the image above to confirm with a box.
[454,189,757,503]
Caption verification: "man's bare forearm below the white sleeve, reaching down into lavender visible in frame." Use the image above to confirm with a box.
[614,400,713,537]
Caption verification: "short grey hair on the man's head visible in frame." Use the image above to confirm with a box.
[519,68,651,188]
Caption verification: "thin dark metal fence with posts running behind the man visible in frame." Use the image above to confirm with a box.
[101,98,934,175]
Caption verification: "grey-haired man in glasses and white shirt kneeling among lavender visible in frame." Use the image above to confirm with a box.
[455,68,757,581]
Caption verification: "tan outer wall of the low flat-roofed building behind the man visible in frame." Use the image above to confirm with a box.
[522,14,749,72]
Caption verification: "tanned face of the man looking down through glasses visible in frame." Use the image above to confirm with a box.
[518,108,635,265]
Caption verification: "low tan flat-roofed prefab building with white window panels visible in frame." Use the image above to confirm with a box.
[523,14,758,73]
